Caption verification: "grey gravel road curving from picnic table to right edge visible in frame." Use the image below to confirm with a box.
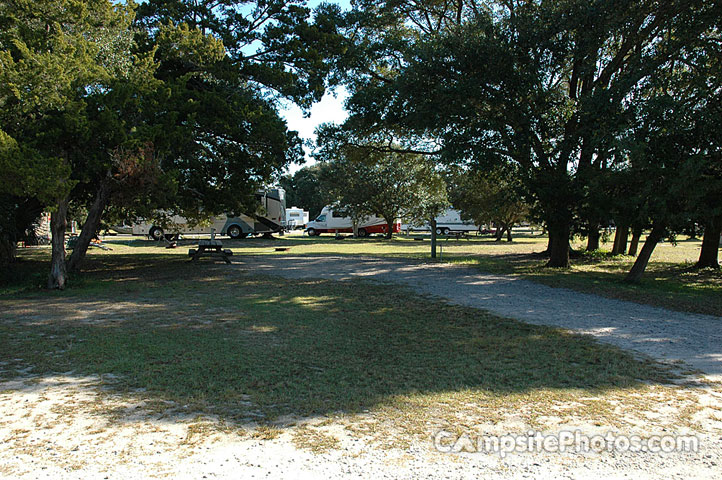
[236,255,722,380]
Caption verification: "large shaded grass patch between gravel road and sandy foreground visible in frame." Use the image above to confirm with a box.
[0,253,683,435]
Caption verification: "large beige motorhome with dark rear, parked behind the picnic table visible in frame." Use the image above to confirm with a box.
[133,188,286,240]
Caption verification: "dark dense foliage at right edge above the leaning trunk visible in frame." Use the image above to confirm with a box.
[617,14,722,235]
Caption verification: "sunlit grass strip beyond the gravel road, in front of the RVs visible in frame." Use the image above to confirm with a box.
[23,232,722,316]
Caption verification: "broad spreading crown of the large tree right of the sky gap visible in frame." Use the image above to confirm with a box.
[338,0,722,266]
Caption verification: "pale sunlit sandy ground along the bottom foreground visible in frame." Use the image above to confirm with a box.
[0,375,722,479]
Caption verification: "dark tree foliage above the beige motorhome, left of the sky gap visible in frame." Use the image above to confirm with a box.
[131,0,348,218]
